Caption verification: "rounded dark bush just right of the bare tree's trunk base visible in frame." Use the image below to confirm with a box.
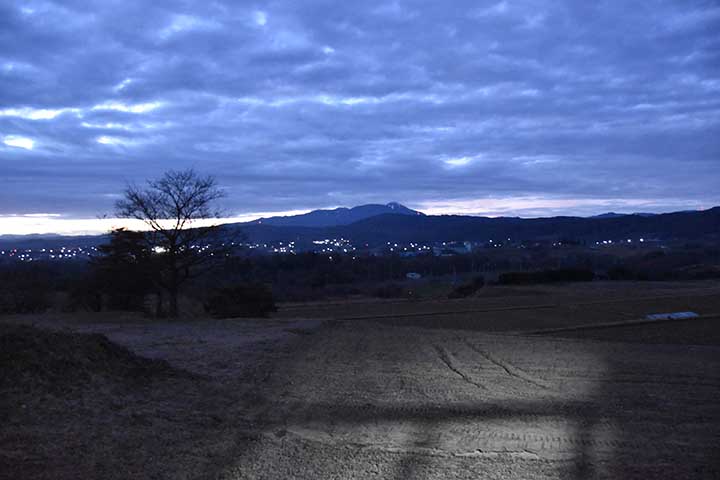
[204,283,277,318]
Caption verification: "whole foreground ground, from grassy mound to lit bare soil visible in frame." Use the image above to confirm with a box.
[0,284,720,479]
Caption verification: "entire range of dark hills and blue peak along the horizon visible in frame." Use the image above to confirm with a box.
[0,204,720,248]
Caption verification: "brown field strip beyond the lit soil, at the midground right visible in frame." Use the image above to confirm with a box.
[276,282,720,332]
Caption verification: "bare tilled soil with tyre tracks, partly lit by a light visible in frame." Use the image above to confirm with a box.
[222,323,720,479]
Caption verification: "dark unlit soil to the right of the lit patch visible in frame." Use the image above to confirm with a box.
[574,328,720,479]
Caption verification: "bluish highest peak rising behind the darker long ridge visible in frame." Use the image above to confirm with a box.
[247,202,425,227]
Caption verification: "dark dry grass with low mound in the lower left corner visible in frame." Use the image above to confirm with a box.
[0,326,250,479]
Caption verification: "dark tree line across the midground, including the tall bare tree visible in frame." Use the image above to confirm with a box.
[0,170,720,318]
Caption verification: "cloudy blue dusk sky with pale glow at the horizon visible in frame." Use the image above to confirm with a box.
[0,0,720,234]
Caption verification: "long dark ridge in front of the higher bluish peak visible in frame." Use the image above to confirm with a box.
[228,207,720,246]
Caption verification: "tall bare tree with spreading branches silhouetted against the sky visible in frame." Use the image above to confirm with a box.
[116,169,224,317]
